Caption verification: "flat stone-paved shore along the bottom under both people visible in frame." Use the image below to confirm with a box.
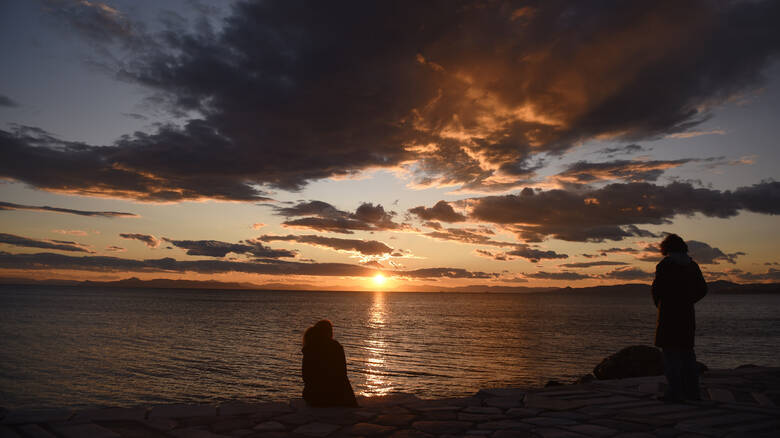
[0,367,780,438]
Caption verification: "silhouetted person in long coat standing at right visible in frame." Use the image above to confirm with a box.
[652,234,707,402]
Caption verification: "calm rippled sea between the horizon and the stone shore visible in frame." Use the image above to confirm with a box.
[0,286,780,408]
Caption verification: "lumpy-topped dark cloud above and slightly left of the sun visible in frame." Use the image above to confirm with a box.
[274,201,404,234]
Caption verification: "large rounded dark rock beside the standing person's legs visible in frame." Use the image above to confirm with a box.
[593,345,664,380]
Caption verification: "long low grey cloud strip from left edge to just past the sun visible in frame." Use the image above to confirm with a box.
[0,251,497,278]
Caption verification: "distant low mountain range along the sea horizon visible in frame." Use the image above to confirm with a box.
[0,277,780,294]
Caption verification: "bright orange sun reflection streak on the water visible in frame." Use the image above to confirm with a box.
[360,292,392,397]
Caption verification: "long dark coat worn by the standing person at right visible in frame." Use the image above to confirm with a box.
[652,253,707,349]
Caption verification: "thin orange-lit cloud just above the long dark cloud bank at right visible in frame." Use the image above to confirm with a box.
[555,159,695,184]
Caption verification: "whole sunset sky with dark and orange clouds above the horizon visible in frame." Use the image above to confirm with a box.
[0,0,780,290]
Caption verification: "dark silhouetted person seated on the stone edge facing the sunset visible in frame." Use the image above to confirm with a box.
[302,319,358,406]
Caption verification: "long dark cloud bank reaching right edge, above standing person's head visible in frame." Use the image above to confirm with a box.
[469,182,780,242]
